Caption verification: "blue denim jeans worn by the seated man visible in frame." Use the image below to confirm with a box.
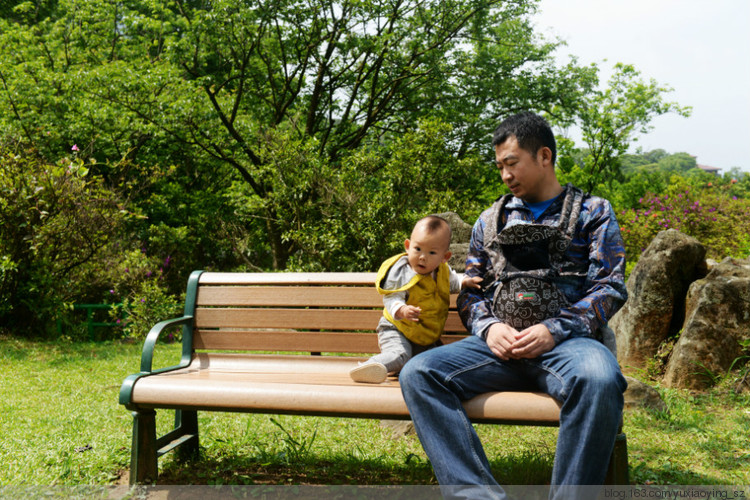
[399,336,627,498]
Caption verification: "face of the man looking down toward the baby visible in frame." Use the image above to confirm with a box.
[495,136,549,203]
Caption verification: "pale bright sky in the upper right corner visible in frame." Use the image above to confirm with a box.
[535,0,750,173]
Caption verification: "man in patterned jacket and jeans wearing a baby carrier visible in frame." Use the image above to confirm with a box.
[400,113,627,498]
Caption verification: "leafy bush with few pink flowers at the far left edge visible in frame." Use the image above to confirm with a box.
[0,148,125,336]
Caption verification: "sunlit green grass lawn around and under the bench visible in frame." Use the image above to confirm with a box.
[0,338,750,485]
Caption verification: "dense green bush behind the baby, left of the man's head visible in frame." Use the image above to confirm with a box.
[276,121,497,271]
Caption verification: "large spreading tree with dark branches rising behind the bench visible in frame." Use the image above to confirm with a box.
[0,0,591,269]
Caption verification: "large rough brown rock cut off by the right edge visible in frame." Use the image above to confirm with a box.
[663,258,750,389]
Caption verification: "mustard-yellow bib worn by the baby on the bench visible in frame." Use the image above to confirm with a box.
[375,253,450,345]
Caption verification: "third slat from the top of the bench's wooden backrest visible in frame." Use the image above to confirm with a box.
[195,307,464,332]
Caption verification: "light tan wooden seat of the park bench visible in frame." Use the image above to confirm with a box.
[133,355,560,425]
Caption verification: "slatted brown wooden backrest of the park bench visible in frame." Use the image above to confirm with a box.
[185,272,466,353]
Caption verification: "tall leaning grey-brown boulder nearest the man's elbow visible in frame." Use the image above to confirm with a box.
[609,229,706,372]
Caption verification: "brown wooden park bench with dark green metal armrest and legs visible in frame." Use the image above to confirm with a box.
[120,271,628,484]
